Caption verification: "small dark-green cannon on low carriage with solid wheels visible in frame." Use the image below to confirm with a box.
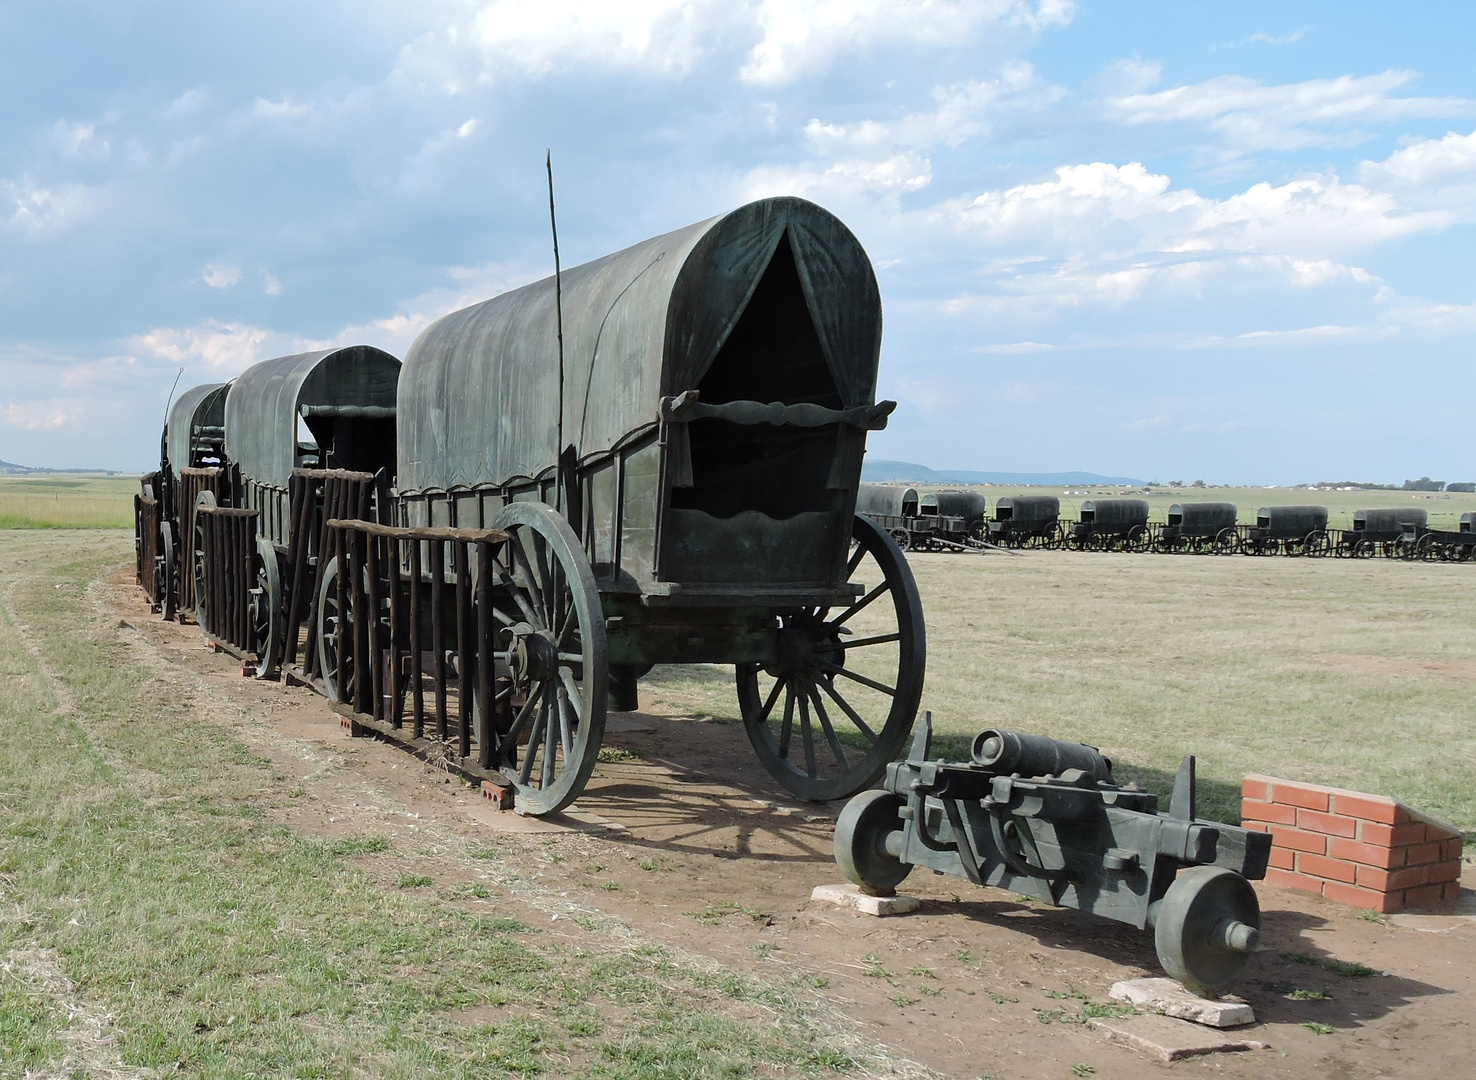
[835,713,1271,996]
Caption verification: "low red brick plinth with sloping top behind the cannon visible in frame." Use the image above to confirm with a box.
[1240,776,1464,912]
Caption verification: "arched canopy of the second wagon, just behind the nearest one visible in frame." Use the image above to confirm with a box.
[226,345,400,490]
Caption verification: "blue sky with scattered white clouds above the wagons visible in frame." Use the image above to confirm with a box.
[0,0,1476,484]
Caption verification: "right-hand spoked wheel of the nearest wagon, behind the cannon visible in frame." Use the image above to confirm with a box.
[738,516,927,803]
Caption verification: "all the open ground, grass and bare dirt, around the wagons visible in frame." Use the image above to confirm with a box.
[0,530,1476,1079]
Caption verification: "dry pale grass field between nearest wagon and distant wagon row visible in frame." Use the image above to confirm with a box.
[644,552,1476,826]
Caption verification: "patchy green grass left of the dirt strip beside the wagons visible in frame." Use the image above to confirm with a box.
[0,533,852,1079]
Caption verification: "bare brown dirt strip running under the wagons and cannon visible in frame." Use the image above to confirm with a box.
[99,575,1476,1080]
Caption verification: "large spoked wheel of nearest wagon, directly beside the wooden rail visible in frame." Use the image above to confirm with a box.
[492,503,610,814]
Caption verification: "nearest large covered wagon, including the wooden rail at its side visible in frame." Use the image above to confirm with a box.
[316,198,925,813]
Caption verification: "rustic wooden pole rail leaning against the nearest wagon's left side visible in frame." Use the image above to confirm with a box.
[319,518,508,783]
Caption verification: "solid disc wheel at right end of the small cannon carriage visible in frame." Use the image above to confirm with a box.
[1153,866,1261,997]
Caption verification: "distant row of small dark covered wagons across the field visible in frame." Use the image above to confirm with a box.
[856,484,1476,562]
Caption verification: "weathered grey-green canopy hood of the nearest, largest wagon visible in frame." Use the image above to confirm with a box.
[399,198,881,493]
